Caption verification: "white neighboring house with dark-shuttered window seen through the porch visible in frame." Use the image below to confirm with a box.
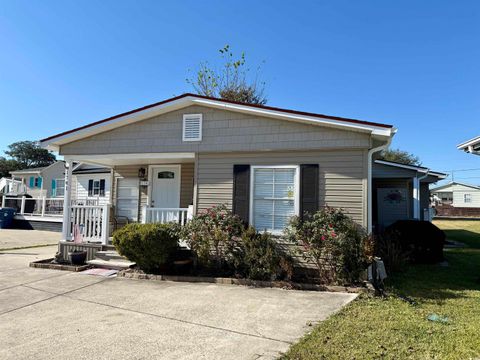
[71,164,112,205]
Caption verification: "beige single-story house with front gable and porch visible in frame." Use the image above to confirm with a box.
[41,94,398,243]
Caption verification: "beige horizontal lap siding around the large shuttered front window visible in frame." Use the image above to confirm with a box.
[197,150,367,225]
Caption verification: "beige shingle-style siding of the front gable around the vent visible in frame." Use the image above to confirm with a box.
[60,105,370,155]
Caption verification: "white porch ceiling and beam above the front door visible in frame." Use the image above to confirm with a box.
[65,153,195,168]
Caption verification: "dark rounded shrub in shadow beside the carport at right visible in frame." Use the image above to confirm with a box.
[384,220,445,264]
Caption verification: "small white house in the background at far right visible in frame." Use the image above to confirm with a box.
[430,181,480,208]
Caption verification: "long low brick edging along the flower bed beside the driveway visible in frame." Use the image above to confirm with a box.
[117,269,368,293]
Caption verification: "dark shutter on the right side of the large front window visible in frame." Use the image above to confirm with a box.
[300,164,319,219]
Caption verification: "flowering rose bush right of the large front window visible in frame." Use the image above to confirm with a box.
[285,207,368,283]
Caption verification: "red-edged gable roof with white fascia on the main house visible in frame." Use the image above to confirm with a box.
[41,93,396,149]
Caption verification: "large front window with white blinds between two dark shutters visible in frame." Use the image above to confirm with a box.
[250,166,299,233]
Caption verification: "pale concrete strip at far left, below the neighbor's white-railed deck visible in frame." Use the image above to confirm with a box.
[0,229,62,250]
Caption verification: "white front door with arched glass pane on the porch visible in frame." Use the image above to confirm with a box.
[150,165,180,208]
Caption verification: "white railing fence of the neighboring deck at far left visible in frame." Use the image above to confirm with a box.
[2,196,63,216]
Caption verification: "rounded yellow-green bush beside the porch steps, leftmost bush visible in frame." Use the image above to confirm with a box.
[113,224,178,273]
